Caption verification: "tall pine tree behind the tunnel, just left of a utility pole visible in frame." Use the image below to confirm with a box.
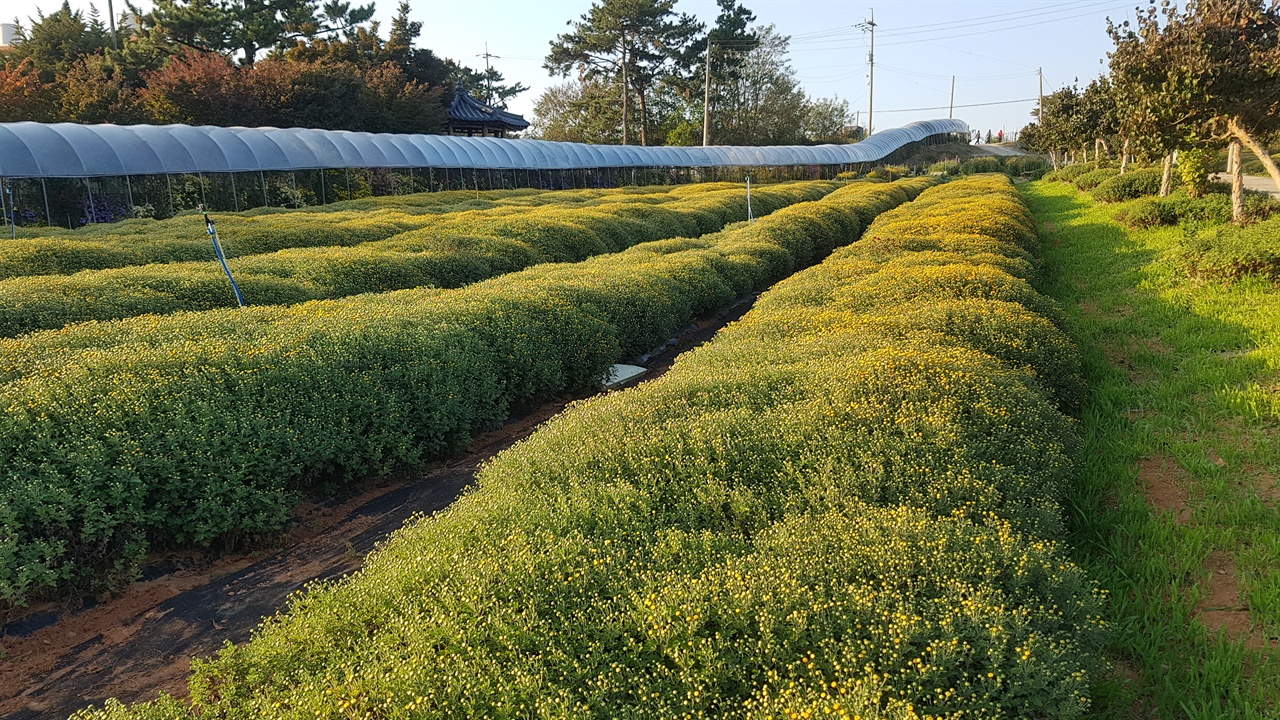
[544,0,703,145]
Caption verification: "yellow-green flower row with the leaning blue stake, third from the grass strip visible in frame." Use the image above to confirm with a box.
[0,182,837,337]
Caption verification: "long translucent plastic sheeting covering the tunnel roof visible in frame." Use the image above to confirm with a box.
[0,119,969,178]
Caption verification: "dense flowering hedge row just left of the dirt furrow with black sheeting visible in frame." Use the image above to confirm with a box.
[0,179,932,603]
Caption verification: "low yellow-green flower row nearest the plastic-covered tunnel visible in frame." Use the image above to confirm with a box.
[0,183,701,278]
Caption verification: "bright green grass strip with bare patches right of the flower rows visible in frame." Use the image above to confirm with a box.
[1025,183,1280,720]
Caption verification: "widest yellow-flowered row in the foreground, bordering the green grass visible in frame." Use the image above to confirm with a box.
[77,178,1102,720]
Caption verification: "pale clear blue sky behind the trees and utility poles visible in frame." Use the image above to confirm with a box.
[0,0,1138,139]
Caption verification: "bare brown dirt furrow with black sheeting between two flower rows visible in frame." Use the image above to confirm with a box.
[0,299,754,720]
